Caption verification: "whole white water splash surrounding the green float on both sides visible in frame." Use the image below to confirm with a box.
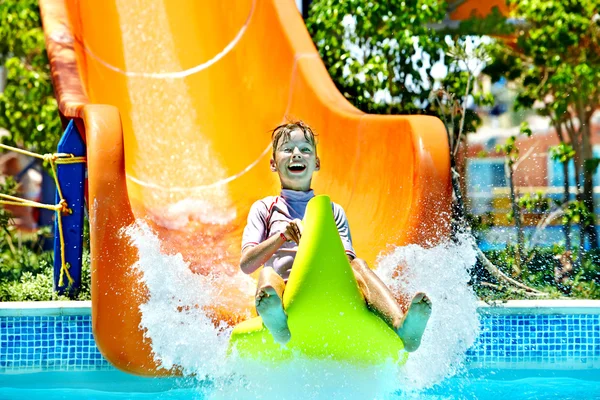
[126,222,479,399]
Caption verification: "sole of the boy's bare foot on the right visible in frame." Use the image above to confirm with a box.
[396,293,431,352]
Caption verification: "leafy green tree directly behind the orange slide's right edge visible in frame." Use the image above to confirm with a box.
[306,0,486,227]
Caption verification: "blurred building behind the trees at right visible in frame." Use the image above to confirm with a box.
[465,78,600,248]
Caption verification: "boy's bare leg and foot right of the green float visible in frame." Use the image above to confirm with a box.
[350,258,431,352]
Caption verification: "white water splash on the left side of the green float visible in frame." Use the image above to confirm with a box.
[126,221,254,379]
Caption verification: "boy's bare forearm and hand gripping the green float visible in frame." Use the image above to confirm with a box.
[240,219,302,274]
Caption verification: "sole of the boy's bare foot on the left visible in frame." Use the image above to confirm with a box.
[256,285,292,344]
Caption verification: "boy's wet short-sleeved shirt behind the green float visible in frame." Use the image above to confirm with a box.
[242,189,356,279]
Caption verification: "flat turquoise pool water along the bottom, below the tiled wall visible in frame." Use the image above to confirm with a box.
[0,369,600,400]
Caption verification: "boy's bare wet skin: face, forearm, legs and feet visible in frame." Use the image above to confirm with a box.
[246,130,431,352]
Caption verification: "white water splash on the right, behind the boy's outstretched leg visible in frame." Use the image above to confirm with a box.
[375,236,479,389]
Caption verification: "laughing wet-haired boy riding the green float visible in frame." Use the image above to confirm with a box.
[240,121,431,352]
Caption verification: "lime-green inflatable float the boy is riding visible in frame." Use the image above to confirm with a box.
[230,196,408,366]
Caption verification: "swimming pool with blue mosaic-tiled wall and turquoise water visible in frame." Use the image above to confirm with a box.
[0,301,600,400]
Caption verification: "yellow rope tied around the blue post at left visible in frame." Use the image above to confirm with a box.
[0,143,86,286]
